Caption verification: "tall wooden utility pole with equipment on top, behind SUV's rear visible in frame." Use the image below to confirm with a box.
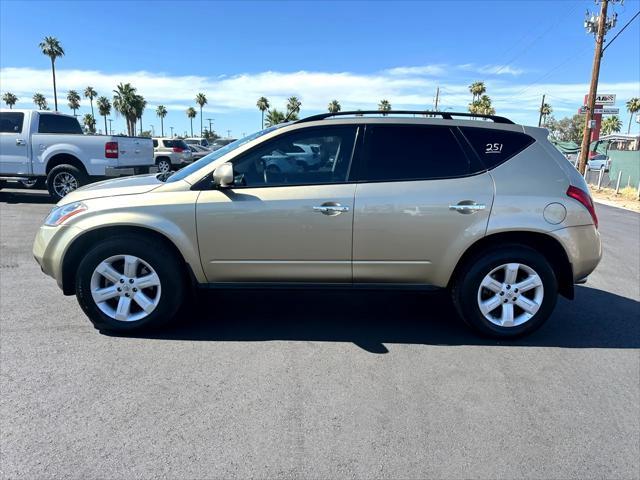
[578,0,617,175]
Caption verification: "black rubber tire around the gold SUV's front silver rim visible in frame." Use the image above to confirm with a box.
[76,235,186,332]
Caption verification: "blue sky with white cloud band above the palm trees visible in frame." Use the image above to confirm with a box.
[0,0,640,136]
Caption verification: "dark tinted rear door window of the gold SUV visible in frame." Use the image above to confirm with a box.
[358,124,484,181]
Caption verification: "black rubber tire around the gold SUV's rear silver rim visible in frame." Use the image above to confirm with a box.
[451,245,558,338]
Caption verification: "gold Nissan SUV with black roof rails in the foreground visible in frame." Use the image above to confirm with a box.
[33,111,601,337]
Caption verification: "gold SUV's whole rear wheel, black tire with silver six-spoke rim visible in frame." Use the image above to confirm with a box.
[451,245,558,337]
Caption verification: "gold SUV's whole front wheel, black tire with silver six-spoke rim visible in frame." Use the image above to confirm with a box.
[76,236,185,332]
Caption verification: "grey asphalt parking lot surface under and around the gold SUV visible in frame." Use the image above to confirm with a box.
[0,190,640,479]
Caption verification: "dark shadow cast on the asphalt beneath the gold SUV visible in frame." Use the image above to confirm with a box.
[106,287,640,354]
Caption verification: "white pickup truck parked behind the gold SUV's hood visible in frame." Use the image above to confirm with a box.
[0,109,155,201]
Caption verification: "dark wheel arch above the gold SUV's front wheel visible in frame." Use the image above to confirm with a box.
[62,225,197,295]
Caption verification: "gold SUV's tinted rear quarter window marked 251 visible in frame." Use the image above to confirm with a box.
[460,127,535,170]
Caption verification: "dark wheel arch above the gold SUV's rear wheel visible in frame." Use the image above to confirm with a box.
[449,231,574,299]
